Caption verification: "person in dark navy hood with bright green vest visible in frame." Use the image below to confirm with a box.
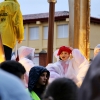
[28,66,50,100]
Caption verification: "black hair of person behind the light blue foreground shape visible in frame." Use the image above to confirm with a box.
[0,60,26,78]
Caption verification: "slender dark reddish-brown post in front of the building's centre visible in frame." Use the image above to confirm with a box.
[47,0,56,64]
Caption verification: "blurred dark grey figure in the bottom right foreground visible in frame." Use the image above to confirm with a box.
[78,53,100,100]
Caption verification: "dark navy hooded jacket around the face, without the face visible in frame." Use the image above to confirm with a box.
[28,66,50,98]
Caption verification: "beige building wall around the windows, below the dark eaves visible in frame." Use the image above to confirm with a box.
[18,20,100,61]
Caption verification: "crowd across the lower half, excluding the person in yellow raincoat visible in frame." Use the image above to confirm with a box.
[0,44,100,100]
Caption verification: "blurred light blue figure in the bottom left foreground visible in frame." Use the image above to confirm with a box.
[0,69,31,100]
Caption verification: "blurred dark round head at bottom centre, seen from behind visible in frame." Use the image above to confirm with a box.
[43,78,78,100]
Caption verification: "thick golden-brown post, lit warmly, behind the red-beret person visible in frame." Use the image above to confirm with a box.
[74,0,90,59]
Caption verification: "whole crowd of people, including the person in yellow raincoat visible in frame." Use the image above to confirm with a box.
[0,0,100,100]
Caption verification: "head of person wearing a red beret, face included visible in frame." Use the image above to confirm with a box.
[57,46,72,60]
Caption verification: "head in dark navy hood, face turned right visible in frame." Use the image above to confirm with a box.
[28,66,50,91]
